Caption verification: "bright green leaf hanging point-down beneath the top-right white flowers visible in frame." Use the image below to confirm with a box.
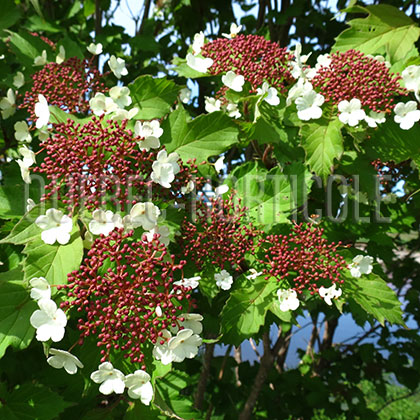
[300,119,343,180]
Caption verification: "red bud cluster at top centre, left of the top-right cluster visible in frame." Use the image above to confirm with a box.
[201,34,294,93]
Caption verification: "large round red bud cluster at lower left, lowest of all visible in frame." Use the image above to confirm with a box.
[59,229,195,370]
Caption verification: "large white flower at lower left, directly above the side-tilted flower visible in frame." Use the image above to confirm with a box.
[29,299,67,343]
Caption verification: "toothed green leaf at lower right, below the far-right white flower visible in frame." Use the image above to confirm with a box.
[342,273,405,326]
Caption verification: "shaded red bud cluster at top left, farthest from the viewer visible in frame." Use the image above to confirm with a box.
[20,57,107,121]
